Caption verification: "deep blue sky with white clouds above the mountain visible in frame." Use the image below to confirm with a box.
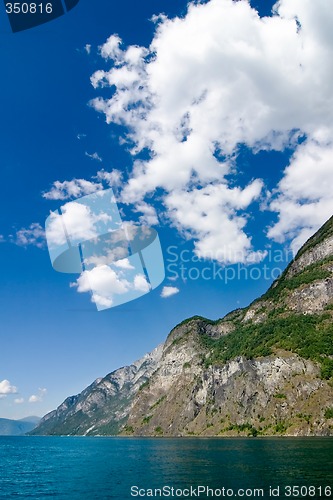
[0,0,333,418]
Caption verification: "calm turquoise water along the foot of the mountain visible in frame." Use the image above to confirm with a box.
[0,437,333,500]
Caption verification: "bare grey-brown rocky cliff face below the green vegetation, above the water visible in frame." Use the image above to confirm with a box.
[124,345,333,436]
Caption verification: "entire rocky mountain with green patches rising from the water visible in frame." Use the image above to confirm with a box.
[33,217,333,436]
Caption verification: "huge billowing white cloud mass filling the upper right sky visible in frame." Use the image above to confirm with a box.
[91,0,333,262]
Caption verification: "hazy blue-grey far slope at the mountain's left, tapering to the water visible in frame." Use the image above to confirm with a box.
[31,346,162,436]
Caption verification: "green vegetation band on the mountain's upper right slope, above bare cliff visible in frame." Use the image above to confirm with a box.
[197,217,333,379]
